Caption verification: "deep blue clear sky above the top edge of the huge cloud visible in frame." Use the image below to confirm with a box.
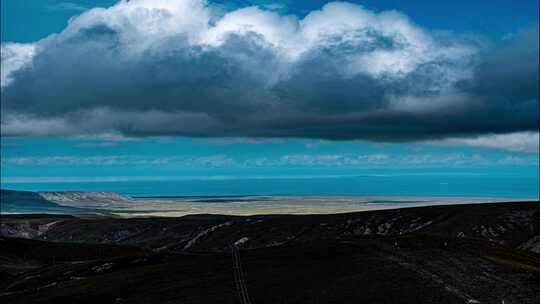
[2,0,538,42]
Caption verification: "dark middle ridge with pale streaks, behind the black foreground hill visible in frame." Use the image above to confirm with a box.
[1,202,540,253]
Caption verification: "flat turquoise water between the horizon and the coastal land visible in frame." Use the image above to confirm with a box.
[2,167,539,199]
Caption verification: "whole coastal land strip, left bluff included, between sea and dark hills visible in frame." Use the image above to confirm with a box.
[1,190,538,218]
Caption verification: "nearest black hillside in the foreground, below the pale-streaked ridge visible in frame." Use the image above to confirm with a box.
[0,235,540,304]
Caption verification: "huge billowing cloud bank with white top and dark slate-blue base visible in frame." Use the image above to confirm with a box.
[1,0,539,141]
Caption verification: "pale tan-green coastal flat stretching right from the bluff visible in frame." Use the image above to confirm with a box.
[111,196,538,217]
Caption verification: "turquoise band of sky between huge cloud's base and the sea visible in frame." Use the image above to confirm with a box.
[2,137,538,183]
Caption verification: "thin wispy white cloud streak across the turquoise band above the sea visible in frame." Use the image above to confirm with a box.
[1,153,538,169]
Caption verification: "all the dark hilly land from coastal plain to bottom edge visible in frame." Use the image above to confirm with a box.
[0,202,540,304]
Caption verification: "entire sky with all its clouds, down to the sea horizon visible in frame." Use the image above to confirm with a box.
[1,0,539,196]
